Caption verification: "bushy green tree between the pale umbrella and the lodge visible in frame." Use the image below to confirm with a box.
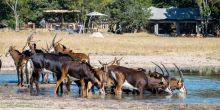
[106,0,150,32]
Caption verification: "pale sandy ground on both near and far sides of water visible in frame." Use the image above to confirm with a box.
[0,55,220,110]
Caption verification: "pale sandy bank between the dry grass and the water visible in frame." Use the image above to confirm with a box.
[1,54,220,73]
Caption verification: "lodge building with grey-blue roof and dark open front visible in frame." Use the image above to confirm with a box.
[148,7,207,36]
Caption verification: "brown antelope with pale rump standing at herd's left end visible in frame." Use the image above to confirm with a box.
[5,46,31,86]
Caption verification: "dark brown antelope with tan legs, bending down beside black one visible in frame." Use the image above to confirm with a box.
[54,61,100,96]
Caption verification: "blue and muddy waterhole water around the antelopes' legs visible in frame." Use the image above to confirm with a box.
[0,72,220,103]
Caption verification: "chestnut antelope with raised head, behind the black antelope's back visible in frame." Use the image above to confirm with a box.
[49,35,90,63]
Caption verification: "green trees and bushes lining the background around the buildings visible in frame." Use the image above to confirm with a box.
[0,0,220,32]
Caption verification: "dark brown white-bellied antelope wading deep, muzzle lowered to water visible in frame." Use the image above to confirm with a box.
[100,62,172,95]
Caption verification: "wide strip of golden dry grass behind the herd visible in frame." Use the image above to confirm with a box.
[0,31,220,56]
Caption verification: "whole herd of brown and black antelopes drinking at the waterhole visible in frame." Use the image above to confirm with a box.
[0,34,187,97]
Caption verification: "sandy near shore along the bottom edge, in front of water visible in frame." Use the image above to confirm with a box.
[0,95,220,110]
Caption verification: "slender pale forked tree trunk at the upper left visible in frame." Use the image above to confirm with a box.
[5,0,20,31]
